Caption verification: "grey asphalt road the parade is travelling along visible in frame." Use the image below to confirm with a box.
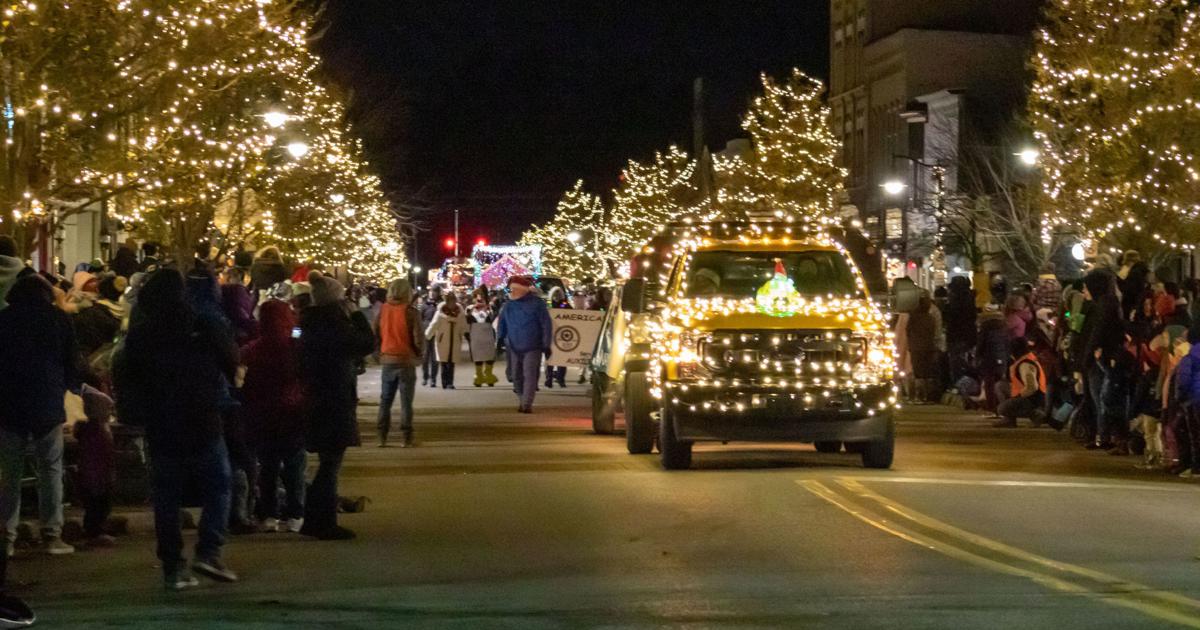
[10,364,1200,629]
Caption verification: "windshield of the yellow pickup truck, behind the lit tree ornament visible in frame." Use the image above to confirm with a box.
[684,250,863,299]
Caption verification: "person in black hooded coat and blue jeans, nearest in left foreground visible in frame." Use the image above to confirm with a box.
[113,269,238,590]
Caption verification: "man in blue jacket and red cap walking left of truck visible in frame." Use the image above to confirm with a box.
[496,276,554,414]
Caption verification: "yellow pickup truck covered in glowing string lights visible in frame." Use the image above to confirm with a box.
[593,223,896,469]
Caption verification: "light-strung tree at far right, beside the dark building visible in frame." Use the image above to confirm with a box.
[1028,0,1200,255]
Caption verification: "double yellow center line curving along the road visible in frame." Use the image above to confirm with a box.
[797,479,1200,629]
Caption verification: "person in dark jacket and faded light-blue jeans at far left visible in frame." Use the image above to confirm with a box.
[0,274,80,556]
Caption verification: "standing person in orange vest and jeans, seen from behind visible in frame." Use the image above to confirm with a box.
[374,278,425,448]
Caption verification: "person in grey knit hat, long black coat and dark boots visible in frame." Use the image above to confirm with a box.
[300,271,374,540]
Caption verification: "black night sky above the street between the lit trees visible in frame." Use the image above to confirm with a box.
[317,0,829,264]
